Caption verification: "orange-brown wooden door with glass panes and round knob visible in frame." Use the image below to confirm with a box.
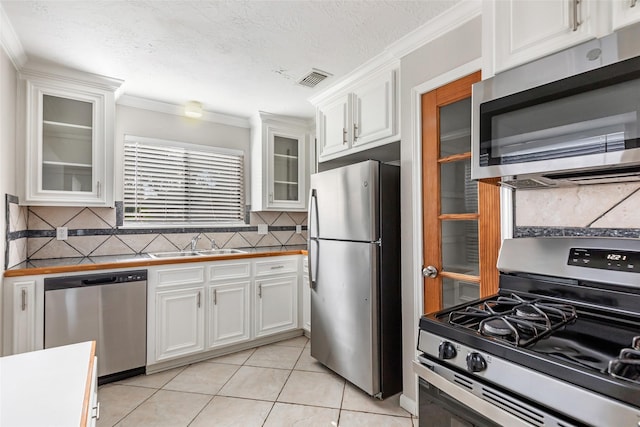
[421,72,500,313]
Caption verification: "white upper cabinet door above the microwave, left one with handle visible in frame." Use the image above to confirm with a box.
[490,0,602,74]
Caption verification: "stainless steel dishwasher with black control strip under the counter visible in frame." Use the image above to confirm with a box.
[44,270,147,384]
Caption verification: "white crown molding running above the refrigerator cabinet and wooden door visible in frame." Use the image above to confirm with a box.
[307,0,482,105]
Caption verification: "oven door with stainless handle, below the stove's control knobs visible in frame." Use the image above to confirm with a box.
[413,361,532,427]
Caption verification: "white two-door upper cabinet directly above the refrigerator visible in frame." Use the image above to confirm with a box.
[311,62,400,162]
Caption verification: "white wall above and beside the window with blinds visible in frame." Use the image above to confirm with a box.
[114,105,251,203]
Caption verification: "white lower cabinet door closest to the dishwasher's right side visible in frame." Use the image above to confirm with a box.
[156,286,204,361]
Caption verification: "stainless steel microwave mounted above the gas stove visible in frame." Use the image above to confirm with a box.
[471,25,640,188]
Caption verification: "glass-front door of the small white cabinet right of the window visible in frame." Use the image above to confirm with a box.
[268,128,306,209]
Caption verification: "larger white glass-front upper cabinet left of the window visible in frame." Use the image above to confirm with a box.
[17,69,121,206]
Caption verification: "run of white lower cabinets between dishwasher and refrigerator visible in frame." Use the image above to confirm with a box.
[147,255,301,365]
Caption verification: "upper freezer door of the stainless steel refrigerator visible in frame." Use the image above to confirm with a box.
[309,160,380,242]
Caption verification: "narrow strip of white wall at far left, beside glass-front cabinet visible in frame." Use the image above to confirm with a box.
[0,45,17,354]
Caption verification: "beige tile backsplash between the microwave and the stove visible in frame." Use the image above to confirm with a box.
[514,183,640,238]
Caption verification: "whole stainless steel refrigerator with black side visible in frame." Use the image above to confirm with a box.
[308,160,402,398]
